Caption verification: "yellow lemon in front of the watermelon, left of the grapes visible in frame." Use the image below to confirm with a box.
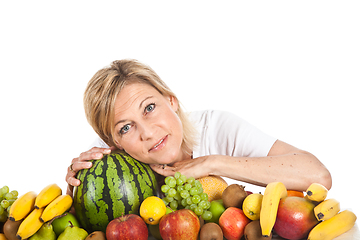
[140,196,166,225]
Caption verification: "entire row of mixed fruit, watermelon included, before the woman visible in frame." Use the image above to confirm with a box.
[0,150,356,240]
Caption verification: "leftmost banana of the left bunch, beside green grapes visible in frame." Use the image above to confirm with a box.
[9,191,36,221]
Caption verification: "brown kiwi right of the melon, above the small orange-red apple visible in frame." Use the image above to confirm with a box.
[222,184,247,209]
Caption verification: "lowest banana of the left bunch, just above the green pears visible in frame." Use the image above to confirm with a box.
[16,208,44,240]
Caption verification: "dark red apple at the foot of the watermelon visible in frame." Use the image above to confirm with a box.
[106,214,149,240]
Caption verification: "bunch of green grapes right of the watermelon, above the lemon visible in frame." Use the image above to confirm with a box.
[161,172,212,220]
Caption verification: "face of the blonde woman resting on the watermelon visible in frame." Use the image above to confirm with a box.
[114,83,183,164]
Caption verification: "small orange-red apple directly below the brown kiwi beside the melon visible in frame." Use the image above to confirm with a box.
[219,207,250,240]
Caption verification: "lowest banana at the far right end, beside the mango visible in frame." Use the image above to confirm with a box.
[308,210,356,240]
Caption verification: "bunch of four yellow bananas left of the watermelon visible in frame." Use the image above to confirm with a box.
[9,184,73,240]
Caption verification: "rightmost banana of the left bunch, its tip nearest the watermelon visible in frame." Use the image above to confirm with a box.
[40,195,73,222]
